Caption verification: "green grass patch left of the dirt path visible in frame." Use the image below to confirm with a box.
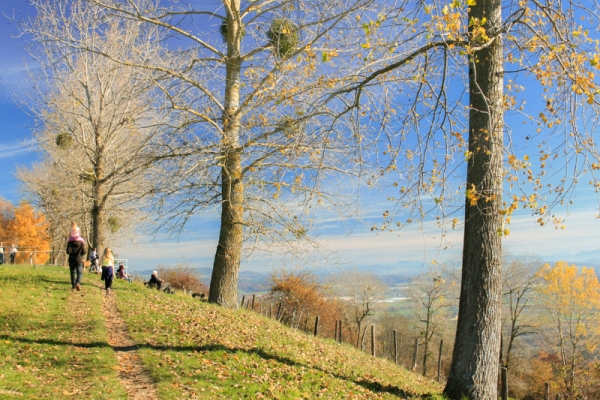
[0,266,126,399]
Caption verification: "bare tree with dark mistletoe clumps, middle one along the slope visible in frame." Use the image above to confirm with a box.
[64,0,383,307]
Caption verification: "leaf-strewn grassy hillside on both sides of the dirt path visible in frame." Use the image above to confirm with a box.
[0,266,441,399]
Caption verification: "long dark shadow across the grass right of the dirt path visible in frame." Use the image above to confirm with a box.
[138,344,430,399]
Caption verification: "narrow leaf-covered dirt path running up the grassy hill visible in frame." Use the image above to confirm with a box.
[102,286,158,400]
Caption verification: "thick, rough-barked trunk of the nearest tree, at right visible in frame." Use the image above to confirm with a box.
[444,0,504,400]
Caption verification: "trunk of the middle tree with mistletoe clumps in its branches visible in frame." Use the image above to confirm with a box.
[208,0,244,308]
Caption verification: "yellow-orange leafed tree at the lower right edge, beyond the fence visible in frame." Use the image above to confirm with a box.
[538,261,600,399]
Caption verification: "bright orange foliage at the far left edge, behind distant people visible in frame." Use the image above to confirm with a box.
[0,199,50,264]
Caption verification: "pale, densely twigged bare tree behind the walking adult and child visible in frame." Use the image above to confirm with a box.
[20,1,163,253]
